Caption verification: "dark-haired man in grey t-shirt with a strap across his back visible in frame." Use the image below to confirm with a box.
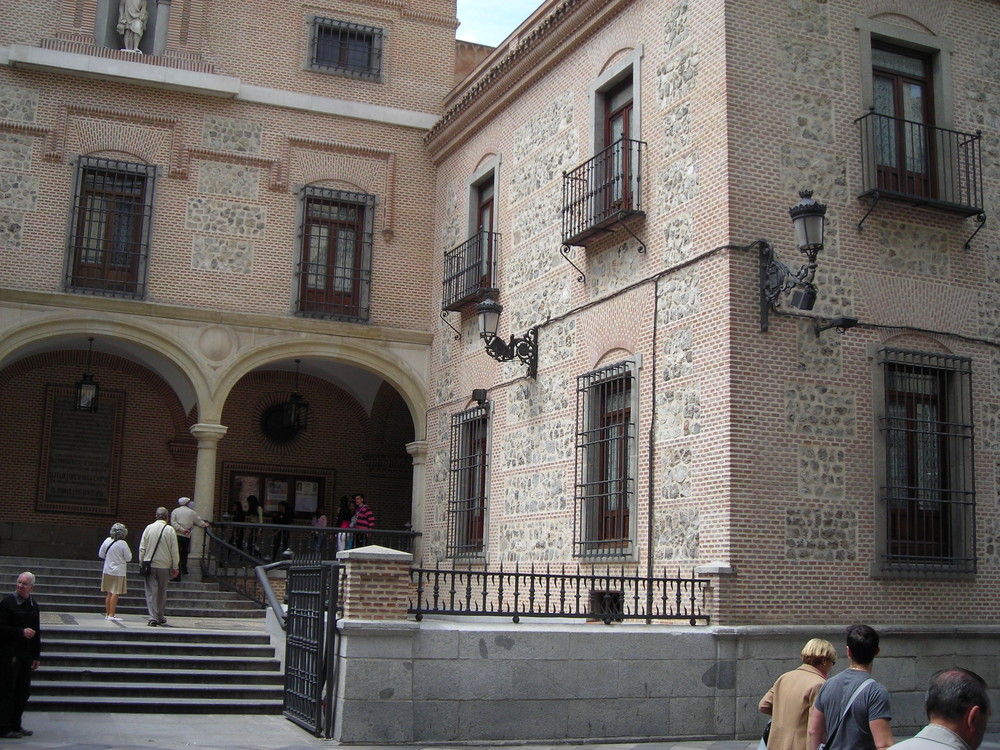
[808,625,892,750]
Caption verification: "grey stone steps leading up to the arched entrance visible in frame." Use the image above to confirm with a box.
[0,558,284,714]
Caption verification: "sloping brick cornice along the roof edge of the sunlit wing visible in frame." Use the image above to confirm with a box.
[424,0,630,161]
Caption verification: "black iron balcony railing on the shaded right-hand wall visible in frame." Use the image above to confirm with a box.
[855,112,984,216]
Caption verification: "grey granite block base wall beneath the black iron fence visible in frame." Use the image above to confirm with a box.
[335,620,1000,744]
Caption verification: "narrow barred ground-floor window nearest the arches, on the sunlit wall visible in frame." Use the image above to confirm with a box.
[448,404,490,557]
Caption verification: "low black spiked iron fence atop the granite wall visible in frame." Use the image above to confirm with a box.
[409,565,709,625]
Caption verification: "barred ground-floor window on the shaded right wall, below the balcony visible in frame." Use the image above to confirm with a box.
[879,349,976,573]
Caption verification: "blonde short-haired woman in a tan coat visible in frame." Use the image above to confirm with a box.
[758,638,837,750]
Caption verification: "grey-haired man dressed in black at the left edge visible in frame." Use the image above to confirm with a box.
[0,571,42,739]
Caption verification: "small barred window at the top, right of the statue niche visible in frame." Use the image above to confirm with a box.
[309,17,383,81]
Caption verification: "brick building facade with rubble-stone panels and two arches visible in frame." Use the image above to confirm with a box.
[0,0,1000,640]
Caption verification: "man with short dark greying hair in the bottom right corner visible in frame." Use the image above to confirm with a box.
[893,667,990,750]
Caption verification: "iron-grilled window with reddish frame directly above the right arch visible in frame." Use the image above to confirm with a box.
[297,187,375,321]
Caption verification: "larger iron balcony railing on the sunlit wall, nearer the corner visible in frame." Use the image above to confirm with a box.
[562,138,645,246]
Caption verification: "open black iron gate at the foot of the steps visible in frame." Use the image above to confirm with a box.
[284,563,340,739]
